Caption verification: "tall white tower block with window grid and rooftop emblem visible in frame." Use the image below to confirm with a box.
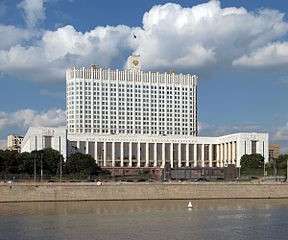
[66,66,197,136]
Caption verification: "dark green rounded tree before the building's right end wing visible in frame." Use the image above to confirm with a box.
[240,153,264,170]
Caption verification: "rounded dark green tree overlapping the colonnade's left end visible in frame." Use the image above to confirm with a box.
[65,153,101,176]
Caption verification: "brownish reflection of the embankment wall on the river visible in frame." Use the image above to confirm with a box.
[0,199,288,216]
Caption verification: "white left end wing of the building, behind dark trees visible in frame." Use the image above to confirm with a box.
[21,127,67,159]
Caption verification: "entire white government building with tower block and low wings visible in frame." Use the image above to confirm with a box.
[22,55,268,168]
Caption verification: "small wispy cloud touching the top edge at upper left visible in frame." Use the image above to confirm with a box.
[17,0,46,29]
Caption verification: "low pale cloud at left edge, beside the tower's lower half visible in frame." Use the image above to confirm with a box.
[0,108,66,130]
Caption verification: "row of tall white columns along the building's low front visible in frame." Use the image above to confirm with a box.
[71,141,240,167]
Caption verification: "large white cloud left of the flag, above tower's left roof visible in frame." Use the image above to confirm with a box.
[0,25,131,82]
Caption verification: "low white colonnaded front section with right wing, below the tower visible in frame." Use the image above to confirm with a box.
[69,133,268,167]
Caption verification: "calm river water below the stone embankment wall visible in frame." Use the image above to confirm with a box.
[0,200,288,240]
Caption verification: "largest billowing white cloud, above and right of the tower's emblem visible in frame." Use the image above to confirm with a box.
[136,1,288,71]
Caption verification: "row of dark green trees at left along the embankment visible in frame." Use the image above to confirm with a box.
[0,148,106,180]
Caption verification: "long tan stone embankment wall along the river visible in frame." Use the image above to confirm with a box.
[0,183,288,202]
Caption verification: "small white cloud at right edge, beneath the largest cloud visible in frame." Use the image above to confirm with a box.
[233,42,288,68]
